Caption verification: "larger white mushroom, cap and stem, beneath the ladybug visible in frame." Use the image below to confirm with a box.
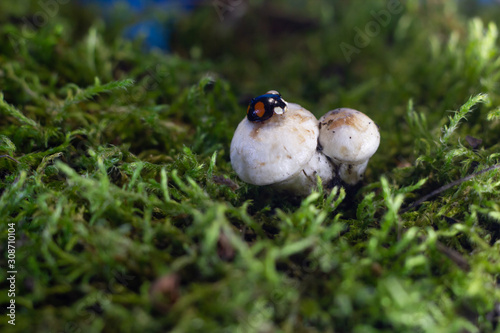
[230,95,333,195]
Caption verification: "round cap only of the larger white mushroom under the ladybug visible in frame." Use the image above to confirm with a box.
[230,103,319,185]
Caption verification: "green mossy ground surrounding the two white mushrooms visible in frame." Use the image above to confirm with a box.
[0,0,500,333]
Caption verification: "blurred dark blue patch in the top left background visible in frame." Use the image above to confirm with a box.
[79,0,203,51]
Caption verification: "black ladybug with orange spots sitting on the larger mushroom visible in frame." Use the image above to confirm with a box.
[247,90,287,122]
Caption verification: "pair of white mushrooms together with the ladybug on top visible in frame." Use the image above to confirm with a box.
[230,90,380,195]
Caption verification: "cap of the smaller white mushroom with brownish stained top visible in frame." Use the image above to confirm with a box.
[319,108,380,164]
